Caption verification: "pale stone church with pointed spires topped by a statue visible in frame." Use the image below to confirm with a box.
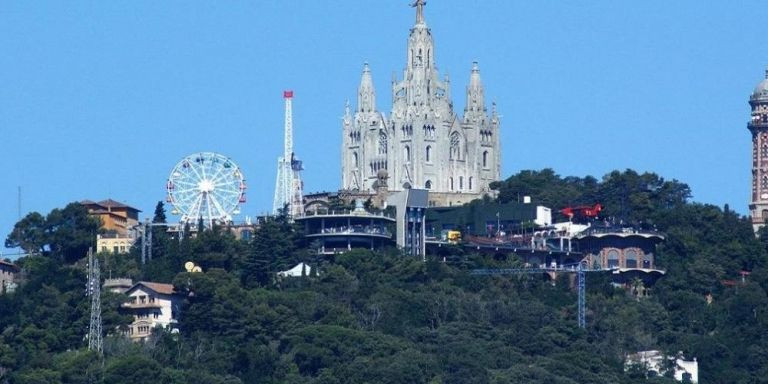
[341,0,501,205]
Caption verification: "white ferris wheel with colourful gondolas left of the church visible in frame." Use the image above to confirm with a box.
[166,152,246,227]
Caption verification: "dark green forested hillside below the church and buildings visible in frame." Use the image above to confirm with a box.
[0,169,768,384]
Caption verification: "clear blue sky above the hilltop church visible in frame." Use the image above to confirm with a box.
[0,0,768,255]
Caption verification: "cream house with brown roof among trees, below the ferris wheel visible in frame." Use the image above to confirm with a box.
[122,281,183,341]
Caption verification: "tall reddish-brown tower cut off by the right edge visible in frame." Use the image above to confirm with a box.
[747,69,768,231]
